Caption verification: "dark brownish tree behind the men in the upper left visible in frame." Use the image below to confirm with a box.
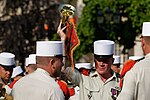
[0,0,60,66]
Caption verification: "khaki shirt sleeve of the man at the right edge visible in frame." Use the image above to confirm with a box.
[117,69,137,100]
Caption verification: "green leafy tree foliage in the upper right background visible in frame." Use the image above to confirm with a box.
[74,0,150,59]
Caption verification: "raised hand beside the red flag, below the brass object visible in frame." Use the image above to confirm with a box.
[57,20,67,41]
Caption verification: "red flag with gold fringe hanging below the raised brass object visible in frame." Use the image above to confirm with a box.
[65,18,80,68]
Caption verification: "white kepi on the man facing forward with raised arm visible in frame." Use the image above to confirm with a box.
[94,40,115,58]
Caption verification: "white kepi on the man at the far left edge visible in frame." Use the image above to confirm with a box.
[0,52,15,66]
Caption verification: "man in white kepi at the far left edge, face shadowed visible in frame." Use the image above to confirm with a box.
[0,52,15,94]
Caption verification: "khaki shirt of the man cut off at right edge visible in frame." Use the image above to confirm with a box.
[117,53,150,100]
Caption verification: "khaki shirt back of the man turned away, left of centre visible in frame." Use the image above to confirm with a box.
[12,68,65,100]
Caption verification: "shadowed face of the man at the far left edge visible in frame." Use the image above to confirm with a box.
[0,66,13,81]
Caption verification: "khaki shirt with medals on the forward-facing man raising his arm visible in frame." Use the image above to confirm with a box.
[65,70,119,100]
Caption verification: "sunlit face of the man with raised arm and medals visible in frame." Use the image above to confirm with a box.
[95,58,113,75]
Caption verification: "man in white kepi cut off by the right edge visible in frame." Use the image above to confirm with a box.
[117,22,150,100]
